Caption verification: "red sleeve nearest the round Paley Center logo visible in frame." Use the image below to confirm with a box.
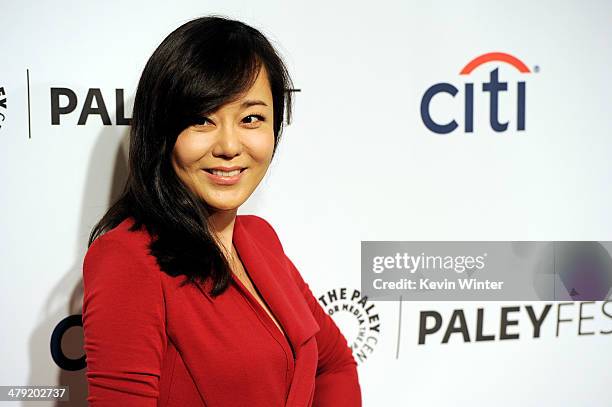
[285,256,361,407]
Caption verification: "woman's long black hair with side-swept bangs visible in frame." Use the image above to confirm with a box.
[88,15,293,296]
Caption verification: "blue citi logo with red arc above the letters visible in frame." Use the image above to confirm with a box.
[421,52,537,134]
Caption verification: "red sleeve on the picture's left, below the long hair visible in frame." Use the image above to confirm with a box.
[82,236,166,407]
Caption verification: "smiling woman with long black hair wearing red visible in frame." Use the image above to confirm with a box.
[83,16,361,406]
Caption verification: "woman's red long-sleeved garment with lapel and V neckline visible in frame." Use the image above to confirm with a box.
[83,215,361,407]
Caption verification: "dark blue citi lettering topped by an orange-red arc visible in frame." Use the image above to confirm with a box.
[421,52,537,134]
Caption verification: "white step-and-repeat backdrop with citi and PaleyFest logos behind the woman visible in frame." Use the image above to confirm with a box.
[0,0,612,406]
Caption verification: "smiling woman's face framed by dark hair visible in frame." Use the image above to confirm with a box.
[172,65,274,210]
